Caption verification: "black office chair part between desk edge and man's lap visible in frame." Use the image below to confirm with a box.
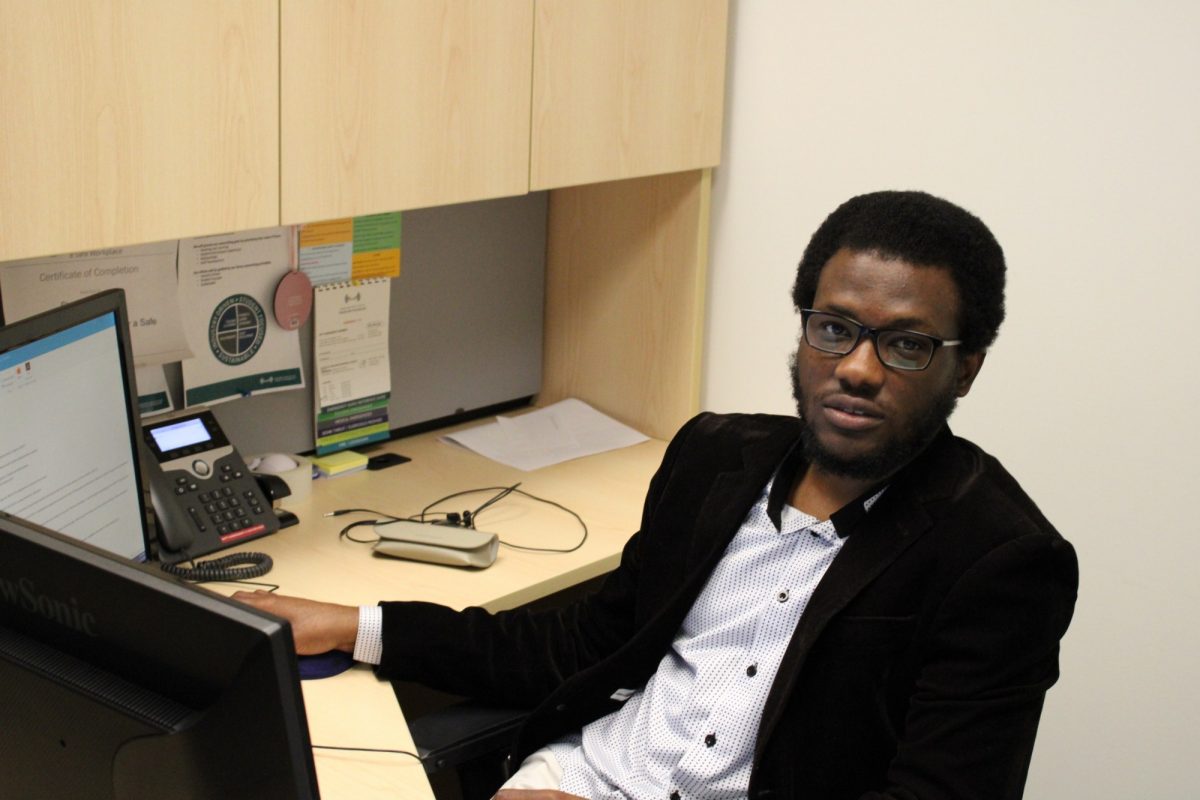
[408,700,529,800]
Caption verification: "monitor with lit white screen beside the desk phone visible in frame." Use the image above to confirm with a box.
[0,289,149,560]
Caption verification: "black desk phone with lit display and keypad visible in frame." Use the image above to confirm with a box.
[142,410,280,564]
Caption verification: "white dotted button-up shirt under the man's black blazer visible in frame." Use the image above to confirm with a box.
[548,483,883,800]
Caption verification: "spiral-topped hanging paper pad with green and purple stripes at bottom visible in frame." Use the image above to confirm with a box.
[313,279,391,456]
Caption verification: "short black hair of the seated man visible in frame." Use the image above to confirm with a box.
[792,192,1006,353]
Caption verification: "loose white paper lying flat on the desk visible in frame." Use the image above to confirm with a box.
[442,398,648,471]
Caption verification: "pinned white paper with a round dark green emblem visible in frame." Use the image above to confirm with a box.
[179,228,304,407]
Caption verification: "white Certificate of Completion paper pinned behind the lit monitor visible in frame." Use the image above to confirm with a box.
[0,240,192,367]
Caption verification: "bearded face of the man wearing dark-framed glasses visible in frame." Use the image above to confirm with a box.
[792,248,983,481]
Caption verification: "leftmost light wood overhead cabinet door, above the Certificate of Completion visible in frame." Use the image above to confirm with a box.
[0,0,278,260]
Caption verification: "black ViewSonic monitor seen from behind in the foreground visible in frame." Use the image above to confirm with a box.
[0,510,318,800]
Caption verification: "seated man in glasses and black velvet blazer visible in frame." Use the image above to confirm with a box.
[239,192,1078,800]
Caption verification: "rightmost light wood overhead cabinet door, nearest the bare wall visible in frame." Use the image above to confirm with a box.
[530,0,728,190]
